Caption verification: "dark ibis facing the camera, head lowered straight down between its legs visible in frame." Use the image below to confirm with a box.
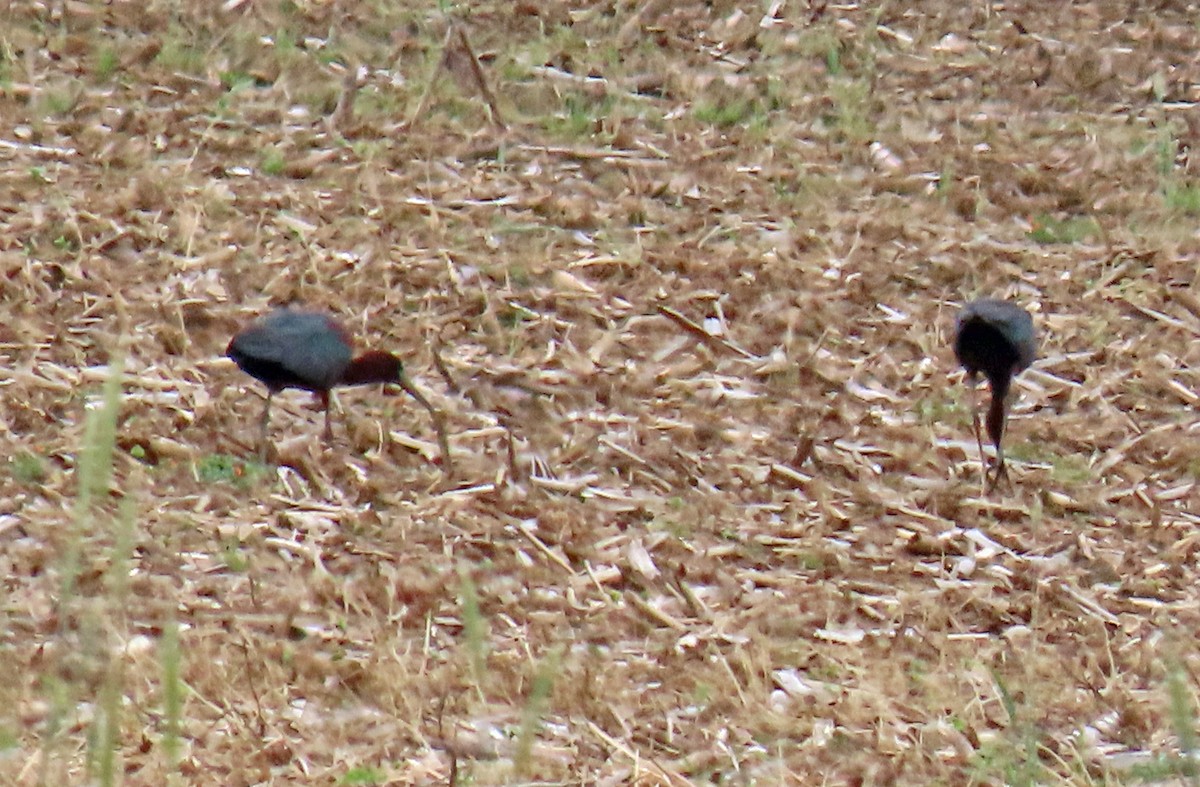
[954,298,1037,493]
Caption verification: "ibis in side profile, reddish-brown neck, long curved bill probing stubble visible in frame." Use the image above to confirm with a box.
[226,308,450,471]
